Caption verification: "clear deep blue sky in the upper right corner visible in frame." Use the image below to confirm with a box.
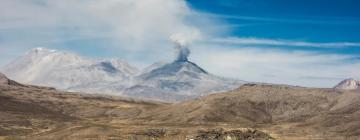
[188,0,360,51]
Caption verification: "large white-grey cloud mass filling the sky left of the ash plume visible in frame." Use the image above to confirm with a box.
[0,0,211,66]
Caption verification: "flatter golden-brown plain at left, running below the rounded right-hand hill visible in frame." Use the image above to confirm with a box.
[0,74,271,140]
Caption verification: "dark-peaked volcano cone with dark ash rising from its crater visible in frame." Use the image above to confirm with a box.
[124,44,244,100]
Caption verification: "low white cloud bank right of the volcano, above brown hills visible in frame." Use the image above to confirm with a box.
[190,45,360,87]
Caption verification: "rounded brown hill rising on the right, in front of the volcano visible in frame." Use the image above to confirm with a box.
[136,84,360,139]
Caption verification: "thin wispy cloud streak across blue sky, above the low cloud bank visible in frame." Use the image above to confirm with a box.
[209,37,360,48]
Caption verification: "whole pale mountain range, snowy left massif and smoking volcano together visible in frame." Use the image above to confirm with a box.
[1,48,245,101]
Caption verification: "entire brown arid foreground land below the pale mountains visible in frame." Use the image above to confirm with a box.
[0,72,360,140]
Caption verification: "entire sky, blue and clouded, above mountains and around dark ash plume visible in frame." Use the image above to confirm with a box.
[0,0,360,87]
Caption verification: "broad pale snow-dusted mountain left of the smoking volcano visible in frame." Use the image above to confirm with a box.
[2,48,138,92]
